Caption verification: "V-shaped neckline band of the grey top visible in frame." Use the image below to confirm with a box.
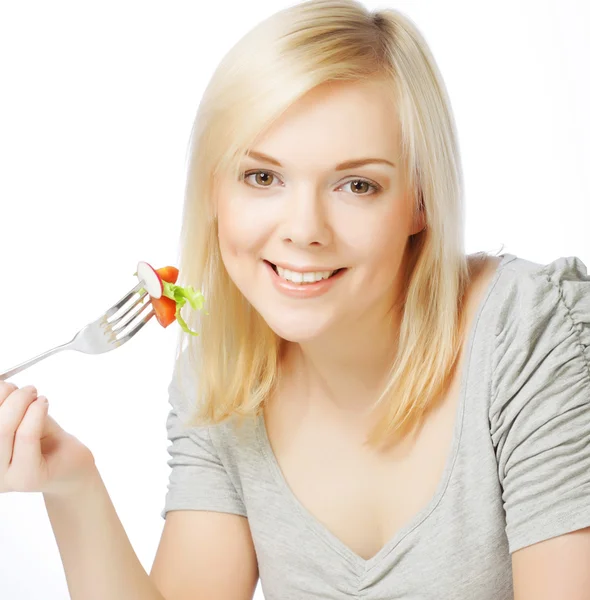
[256,253,517,575]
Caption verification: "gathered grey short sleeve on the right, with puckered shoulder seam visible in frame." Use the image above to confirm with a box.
[489,257,590,553]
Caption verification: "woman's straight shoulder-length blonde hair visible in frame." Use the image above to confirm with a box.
[177,0,492,445]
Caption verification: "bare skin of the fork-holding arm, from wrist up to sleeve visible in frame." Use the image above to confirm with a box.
[43,470,258,600]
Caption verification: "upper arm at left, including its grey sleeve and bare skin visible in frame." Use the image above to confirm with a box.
[150,350,258,600]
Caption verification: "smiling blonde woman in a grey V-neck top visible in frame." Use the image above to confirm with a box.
[0,1,590,600]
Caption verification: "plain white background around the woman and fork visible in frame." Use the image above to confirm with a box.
[0,0,590,600]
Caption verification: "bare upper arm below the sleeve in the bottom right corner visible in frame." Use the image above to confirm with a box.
[512,527,590,600]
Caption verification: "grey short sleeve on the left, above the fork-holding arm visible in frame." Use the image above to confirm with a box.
[161,351,246,519]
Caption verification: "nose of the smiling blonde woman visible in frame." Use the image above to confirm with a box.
[282,190,331,248]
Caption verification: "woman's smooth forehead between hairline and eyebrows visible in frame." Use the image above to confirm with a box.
[243,81,399,170]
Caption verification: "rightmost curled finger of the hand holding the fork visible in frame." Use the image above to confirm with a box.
[7,396,48,491]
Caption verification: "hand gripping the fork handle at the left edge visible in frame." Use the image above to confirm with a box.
[0,381,95,495]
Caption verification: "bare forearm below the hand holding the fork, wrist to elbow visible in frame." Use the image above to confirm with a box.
[43,469,166,600]
